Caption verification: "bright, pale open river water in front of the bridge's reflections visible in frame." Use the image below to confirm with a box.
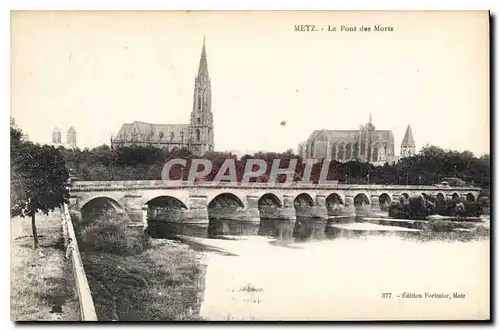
[184,223,490,320]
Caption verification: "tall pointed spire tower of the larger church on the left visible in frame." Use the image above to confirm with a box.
[189,37,214,155]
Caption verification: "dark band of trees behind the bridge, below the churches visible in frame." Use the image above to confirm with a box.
[61,146,490,189]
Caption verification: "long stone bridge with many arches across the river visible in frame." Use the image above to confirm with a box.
[69,181,480,236]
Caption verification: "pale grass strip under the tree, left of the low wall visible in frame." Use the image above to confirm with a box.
[10,211,80,321]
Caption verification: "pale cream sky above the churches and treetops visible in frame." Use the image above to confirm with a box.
[11,12,490,155]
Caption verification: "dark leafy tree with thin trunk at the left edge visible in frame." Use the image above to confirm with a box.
[10,127,69,248]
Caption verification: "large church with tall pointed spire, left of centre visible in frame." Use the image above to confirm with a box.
[111,38,214,155]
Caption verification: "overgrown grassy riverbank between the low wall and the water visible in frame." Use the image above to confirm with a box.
[72,215,204,321]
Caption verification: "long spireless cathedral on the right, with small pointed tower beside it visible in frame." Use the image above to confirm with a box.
[298,115,415,165]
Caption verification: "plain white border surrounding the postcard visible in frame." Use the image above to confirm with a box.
[0,0,500,330]
